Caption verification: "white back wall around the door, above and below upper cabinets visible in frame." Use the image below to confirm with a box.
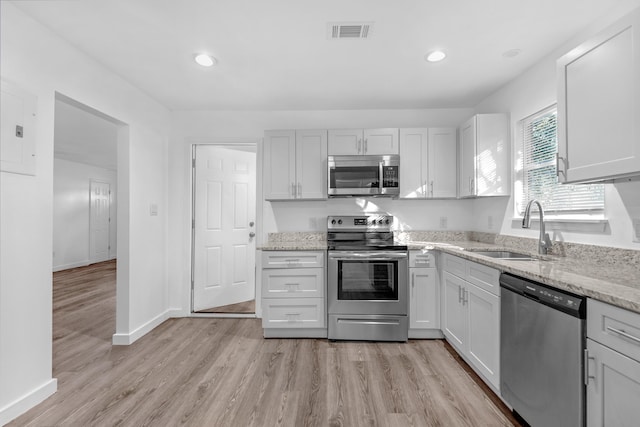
[169,108,473,314]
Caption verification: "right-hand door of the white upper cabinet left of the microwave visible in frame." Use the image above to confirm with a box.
[296,130,328,199]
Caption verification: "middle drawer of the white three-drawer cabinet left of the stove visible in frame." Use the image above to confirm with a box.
[262,268,325,298]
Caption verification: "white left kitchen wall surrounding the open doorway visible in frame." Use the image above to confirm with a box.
[0,1,170,424]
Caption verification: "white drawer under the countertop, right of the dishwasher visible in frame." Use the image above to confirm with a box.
[587,298,640,361]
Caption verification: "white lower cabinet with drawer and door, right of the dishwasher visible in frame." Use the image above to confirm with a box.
[585,299,640,427]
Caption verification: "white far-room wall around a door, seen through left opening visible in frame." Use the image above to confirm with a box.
[53,159,118,271]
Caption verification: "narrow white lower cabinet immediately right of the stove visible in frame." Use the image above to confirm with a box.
[409,251,442,338]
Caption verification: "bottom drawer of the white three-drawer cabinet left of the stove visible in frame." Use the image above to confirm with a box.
[262,298,327,328]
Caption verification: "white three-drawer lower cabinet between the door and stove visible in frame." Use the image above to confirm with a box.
[262,251,327,338]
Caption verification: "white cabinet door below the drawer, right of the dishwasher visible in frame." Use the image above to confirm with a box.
[586,339,640,427]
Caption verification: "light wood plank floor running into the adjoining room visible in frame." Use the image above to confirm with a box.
[10,262,518,426]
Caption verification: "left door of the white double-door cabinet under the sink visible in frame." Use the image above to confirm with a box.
[441,271,468,353]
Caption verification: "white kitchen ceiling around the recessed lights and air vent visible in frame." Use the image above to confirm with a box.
[14,0,630,110]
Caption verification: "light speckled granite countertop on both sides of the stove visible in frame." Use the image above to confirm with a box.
[259,232,640,313]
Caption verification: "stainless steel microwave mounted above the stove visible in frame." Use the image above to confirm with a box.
[327,154,400,197]
